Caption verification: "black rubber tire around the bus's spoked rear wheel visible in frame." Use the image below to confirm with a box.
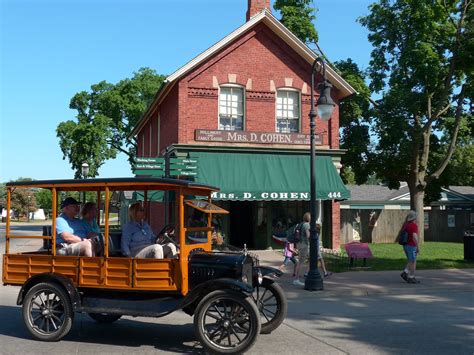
[23,282,74,341]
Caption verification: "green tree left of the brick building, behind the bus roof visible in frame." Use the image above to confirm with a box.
[56,68,164,178]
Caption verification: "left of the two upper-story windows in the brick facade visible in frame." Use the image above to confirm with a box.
[219,86,244,131]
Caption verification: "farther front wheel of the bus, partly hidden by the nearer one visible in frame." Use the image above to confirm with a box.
[252,279,288,334]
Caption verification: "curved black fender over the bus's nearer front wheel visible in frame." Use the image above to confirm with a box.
[179,278,253,315]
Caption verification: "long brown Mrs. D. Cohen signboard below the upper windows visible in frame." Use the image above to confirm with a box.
[194,129,322,145]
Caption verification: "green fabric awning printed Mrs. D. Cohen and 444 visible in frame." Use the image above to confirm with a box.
[189,152,350,201]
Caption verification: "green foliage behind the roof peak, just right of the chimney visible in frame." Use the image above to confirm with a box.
[273,0,318,43]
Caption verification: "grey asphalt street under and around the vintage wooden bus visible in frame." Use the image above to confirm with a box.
[0,224,474,354]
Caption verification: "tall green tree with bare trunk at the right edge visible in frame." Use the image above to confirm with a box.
[359,0,474,241]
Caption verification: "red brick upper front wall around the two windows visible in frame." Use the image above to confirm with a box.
[179,24,339,148]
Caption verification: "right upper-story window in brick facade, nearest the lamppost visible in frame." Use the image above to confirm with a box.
[276,90,300,133]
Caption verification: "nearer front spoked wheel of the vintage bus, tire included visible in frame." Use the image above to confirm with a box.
[194,290,260,354]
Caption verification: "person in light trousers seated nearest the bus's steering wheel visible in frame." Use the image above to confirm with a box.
[121,202,176,259]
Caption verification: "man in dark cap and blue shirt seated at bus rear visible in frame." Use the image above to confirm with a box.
[56,197,92,256]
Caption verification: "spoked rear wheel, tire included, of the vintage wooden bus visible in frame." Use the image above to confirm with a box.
[23,283,74,341]
